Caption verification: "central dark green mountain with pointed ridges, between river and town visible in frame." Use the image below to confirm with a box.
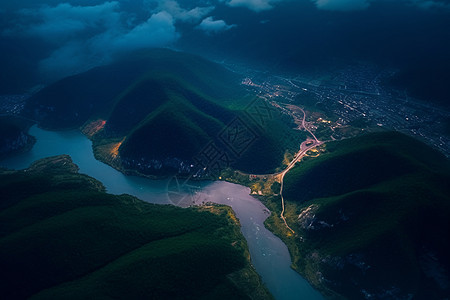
[24,49,304,177]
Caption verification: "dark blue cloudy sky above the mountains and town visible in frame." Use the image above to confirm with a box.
[0,0,450,95]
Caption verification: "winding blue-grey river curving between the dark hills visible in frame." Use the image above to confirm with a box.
[0,126,323,300]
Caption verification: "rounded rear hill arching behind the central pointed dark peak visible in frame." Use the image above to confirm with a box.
[24,49,250,129]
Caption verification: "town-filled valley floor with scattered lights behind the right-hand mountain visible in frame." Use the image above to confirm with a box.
[237,62,450,156]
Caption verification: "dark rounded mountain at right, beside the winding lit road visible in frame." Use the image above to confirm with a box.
[284,132,450,299]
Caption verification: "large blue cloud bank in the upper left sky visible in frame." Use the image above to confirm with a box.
[3,1,179,80]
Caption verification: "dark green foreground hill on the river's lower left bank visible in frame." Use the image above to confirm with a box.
[0,156,270,299]
